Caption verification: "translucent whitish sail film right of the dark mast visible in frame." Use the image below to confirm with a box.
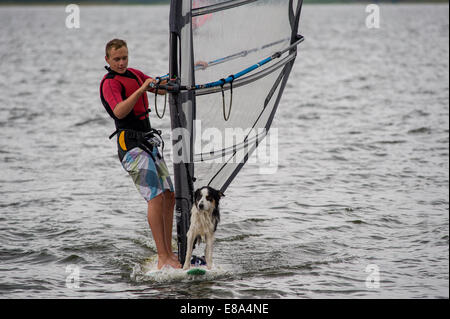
[192,0,296,191]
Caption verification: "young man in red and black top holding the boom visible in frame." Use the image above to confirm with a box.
[100,39,181,269]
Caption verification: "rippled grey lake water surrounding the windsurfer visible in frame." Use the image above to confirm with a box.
[0,4,449,298]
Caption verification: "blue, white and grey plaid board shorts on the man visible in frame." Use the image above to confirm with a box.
[122,142,174,201]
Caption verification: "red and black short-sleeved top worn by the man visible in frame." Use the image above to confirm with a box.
[100,67,151,133]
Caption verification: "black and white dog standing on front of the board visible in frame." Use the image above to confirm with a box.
[183,186,225,269]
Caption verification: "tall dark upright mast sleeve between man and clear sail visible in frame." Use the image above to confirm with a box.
[169,0,195,264]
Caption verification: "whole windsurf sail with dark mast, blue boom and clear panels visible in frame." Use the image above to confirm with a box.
[164,0,303,264]
